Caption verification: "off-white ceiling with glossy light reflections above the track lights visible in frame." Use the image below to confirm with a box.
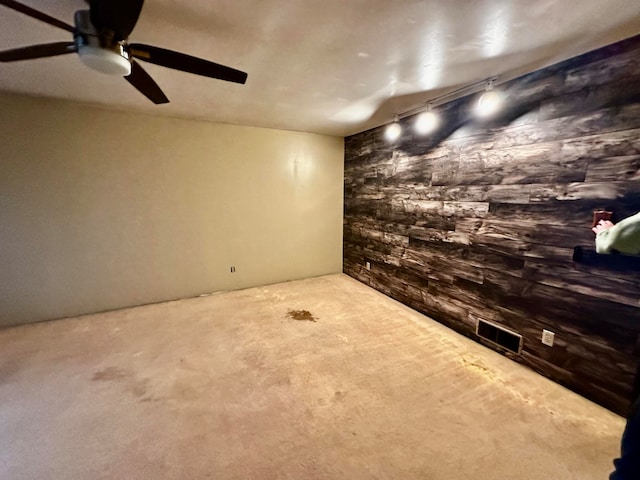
[0,0,640,136]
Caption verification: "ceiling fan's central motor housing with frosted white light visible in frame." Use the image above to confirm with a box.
[74,10,131,77]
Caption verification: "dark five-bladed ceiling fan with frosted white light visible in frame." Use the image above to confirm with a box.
[0,0,247,104]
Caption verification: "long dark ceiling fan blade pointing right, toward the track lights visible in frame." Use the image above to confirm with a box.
[129,43,247,83]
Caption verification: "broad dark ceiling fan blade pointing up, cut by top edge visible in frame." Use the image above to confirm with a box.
[89,0,144,42]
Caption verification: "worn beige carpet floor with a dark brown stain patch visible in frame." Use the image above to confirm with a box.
[0,275,624,480]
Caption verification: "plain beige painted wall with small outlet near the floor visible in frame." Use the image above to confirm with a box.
[0,95,344,325]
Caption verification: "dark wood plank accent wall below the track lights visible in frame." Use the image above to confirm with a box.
[344,36,640,414]
